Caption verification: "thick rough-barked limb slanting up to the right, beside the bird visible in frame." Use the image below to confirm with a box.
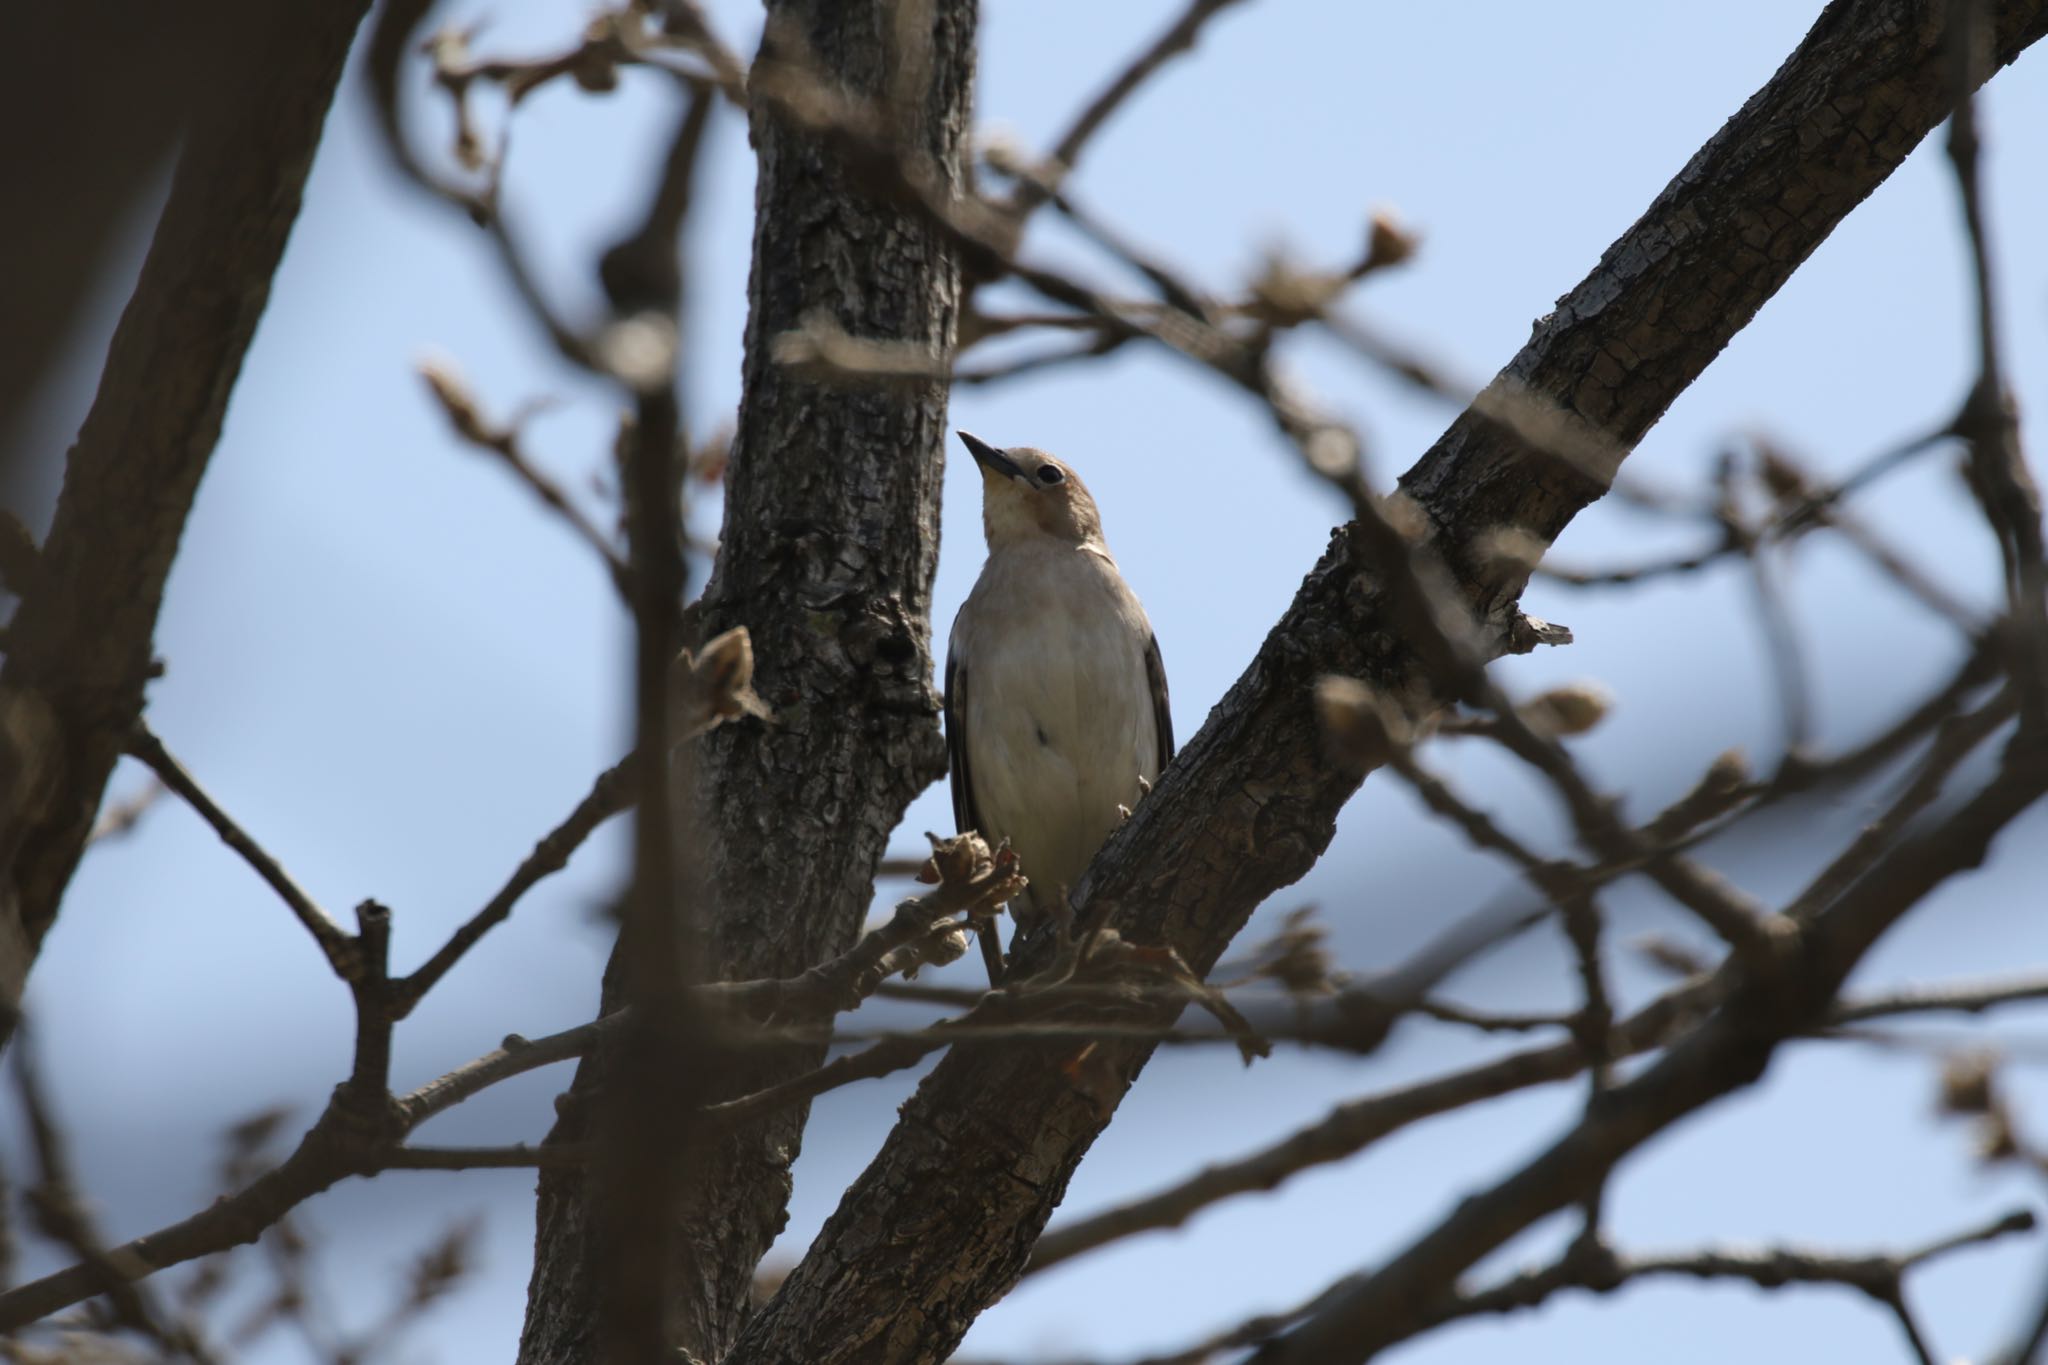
[727,0,2048,1365]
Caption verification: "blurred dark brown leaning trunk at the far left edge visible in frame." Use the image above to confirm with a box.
[0,0,369,1040]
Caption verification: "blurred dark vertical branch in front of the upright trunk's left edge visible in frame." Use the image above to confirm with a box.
[589,72,716,1361]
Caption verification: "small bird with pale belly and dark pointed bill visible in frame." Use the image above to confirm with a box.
[944,432,1174,986]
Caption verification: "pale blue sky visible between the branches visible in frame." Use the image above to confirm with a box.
[8,0,2048,1365]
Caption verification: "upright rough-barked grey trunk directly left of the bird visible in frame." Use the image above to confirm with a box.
[520,0,975,1365]
